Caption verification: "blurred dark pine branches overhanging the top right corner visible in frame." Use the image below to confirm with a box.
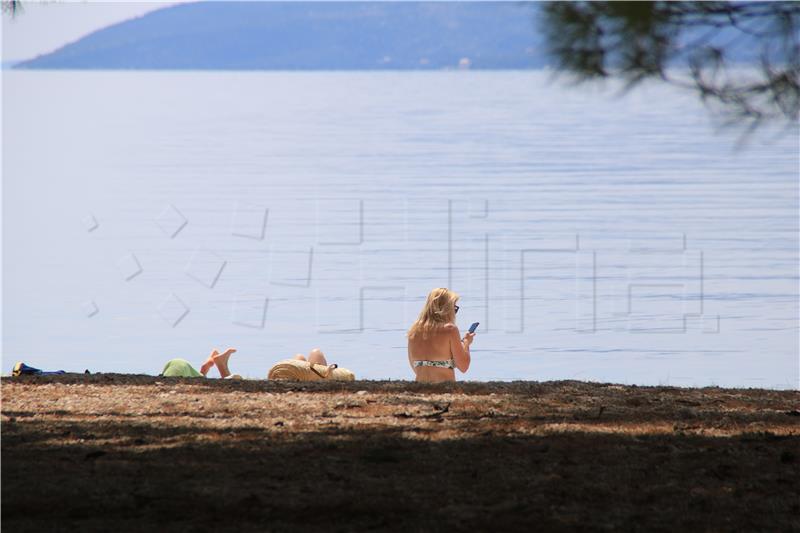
[541,2,800,128]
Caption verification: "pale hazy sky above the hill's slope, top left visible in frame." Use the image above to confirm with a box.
[2,0,187,61]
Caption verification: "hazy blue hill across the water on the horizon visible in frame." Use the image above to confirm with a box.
[13,2,546,70]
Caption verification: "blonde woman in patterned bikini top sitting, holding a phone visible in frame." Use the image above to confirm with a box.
[408,288,475,382]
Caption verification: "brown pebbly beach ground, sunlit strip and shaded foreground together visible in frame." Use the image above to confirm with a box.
[2,374,800,531]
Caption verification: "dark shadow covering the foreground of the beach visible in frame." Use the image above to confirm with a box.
[2,376,800,531]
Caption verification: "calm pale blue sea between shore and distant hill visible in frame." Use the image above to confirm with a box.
[2,71,800,388]
